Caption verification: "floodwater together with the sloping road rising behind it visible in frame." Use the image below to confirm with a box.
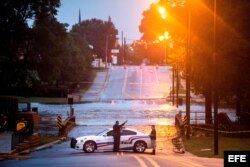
[21,66,236,134]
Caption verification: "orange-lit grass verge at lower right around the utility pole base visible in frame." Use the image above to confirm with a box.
[185,136,250,158]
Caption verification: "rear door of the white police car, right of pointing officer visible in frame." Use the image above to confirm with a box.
[120,129,137,150]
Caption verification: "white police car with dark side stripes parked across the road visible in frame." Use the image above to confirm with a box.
[70,128,152,153]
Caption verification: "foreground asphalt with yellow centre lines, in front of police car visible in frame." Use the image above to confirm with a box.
[0,141,223,167]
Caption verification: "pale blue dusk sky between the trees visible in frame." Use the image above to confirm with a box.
[57,0,158,43]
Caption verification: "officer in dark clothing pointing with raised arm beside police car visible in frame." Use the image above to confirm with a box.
[113,121,127,152]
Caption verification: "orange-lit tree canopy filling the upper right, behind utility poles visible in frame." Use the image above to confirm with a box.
[139,0,250,117]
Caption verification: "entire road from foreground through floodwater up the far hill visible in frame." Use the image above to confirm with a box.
[0,66,223,167]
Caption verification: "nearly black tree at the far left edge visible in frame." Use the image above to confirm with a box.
[0,0,60,90]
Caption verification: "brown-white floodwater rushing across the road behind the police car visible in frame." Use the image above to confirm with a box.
[19,100,236,134]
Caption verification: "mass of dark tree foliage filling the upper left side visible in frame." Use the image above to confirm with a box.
[0,0,91,94]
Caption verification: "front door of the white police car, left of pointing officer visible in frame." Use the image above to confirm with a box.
[98,130,114,151]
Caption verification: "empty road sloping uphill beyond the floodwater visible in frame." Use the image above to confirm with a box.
[81,66,171,101]
